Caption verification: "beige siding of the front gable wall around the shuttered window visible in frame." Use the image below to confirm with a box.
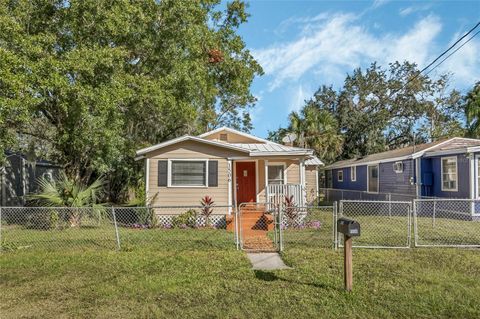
[148,141,244,206]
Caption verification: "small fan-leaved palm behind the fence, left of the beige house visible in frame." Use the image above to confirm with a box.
[29,173,103,226]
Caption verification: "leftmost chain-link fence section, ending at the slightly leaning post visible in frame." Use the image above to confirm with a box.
[0,207,117,251]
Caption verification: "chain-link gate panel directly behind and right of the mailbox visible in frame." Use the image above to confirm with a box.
[335,200,412,248]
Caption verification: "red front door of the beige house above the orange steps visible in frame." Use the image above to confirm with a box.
[235,162,257,204]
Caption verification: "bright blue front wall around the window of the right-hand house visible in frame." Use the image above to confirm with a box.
[421,154,470,198]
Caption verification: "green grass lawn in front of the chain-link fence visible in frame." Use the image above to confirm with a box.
[0,242,480,318]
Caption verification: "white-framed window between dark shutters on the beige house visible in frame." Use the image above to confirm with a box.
[170,160,207,186]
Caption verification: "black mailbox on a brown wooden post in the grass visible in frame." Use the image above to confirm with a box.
[337,217,360,291]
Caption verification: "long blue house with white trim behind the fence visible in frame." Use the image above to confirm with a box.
[324,137,480,199]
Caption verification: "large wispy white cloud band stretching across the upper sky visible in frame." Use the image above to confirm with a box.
[253,14,458,91]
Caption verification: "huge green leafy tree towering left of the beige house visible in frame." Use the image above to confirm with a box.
[0,0,262,199]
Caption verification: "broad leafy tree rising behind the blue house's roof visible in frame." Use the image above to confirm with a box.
[270,62,464,163]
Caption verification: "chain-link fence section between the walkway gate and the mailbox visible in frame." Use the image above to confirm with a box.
[280,203,337,250]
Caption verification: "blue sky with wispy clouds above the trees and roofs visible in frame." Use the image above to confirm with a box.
[239,0,480,137]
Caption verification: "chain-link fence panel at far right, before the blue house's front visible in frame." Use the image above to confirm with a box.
[414,199,480,247]
